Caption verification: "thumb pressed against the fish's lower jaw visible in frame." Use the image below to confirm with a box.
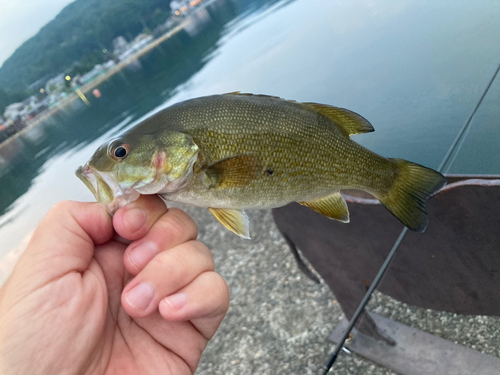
[12,201,113,290]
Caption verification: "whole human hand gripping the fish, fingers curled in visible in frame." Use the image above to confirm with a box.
[0,196,229,375]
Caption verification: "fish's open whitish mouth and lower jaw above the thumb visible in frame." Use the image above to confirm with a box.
[75,163,140,215]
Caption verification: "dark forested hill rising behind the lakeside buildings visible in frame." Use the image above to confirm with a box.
[0,0,170,91]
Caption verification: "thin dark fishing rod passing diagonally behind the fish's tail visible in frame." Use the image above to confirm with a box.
[322,64,500,375]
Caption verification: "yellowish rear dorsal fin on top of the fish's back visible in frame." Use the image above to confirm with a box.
[302,103,375,136]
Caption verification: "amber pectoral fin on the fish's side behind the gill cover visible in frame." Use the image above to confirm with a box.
[205,154,262,188]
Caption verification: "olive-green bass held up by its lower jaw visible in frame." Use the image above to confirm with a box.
[76,92,446,238]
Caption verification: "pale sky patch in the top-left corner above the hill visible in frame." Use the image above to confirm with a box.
[0,0,74,65]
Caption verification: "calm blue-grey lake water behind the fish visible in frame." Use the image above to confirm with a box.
[0,0,500,282]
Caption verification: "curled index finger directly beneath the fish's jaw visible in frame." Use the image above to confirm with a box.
[113,195,168,241]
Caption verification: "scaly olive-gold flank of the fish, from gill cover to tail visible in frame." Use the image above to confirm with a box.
[164,96,393,208]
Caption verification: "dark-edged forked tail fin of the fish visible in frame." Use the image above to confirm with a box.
[377,159,446,232]
